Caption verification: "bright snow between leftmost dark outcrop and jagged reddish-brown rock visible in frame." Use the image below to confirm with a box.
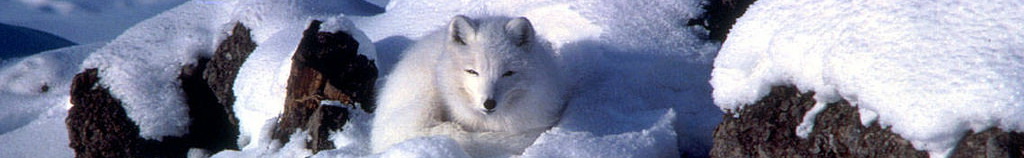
[228,1,377,151]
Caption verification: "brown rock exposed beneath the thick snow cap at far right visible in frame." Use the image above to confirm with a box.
[711,87,1024,157]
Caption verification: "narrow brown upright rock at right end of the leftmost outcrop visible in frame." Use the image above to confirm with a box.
[203,23,256,126]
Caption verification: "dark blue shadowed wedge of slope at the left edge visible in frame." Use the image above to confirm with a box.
[0,24,75,60]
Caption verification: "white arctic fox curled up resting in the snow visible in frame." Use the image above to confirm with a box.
[371,15,564,157]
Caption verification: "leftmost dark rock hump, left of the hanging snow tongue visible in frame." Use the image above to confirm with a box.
[65,69,138,157]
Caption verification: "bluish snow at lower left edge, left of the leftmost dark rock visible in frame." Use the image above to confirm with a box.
[0,43,103,157]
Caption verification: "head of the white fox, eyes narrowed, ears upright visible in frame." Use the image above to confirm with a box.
[438,15,543,115]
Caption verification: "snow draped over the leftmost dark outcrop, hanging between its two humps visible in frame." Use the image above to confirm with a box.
[82,3,227,140]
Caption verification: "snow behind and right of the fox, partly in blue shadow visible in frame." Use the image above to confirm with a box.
[335,0,721,157]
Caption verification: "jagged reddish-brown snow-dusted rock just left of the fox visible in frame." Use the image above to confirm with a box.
[271,21,377,153]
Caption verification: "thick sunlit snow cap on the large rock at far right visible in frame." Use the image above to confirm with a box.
[711,0,1024,157]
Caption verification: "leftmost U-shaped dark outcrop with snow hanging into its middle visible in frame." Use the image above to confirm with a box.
[66,24,255,157]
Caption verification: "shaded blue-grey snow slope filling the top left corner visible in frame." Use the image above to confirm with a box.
[0,0,185,43]
